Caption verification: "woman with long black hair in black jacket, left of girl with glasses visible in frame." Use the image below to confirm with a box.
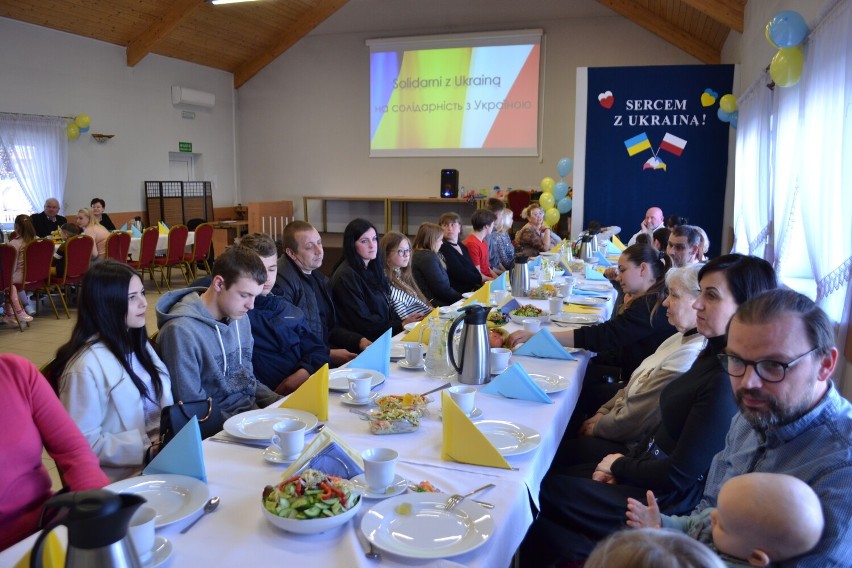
[331,219,423,341]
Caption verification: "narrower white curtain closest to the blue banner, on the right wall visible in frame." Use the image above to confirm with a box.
[733,73,773,257]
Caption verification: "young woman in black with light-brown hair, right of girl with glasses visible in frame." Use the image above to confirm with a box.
[411,223,462,306]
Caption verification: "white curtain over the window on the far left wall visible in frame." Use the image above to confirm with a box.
[0,115,68,211]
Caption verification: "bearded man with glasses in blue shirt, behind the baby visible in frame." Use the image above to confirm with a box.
[693,289,852,567]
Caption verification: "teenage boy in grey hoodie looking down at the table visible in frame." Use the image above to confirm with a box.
[157,246,281,419]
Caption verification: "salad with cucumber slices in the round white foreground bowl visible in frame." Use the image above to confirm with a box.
[263,469,361,519]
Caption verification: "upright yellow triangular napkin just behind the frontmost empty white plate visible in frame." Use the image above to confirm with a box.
[441,391,512,469]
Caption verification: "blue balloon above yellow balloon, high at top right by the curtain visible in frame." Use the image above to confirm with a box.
[764,10,808,87]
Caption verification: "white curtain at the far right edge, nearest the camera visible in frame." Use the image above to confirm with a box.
[798,1,852,322]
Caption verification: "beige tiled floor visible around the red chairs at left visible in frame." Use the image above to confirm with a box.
[0,274,184,489]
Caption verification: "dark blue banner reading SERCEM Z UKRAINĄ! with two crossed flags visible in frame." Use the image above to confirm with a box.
[583,65,734,256]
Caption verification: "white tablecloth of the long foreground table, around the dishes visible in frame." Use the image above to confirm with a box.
[0,278,615,568]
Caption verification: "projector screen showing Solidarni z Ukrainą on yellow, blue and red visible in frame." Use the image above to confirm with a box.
[367,30,542,157]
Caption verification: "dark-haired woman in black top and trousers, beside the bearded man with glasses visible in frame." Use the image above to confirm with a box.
[521,254,776,566]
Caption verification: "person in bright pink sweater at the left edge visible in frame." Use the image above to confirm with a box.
[0,354,109,550]
